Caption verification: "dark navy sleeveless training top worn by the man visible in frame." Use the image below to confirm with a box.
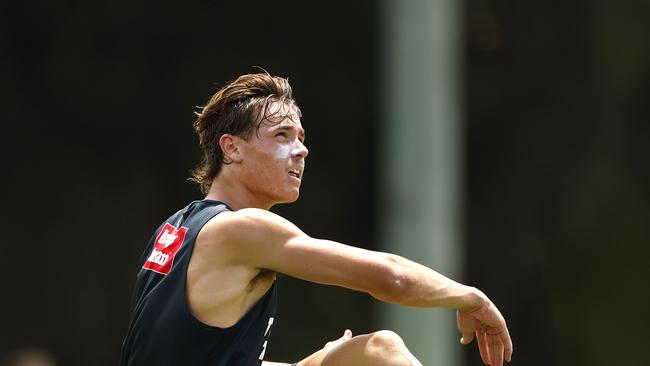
[121,200,276,366]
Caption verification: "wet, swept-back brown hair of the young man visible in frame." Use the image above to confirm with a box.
[190,73,300,193]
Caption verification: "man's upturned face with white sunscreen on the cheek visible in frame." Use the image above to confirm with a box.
[241,103,308,205]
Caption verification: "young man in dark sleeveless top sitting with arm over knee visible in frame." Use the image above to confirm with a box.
[122,73,512,366]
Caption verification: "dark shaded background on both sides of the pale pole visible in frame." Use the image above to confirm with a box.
[0,0,650,366]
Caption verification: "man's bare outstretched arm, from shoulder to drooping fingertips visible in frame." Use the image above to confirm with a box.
[203,209,512,364]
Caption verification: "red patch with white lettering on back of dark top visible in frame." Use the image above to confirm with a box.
[142,223,187,275]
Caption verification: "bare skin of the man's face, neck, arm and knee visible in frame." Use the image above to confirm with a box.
[187,103,512,366]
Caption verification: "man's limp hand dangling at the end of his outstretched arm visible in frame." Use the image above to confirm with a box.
[456,297,512,366]
